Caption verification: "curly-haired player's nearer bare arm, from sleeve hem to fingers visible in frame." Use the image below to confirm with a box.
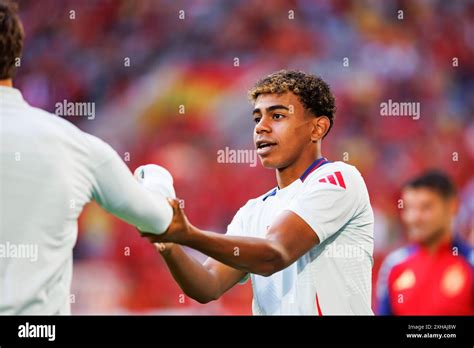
[141,200,319,276]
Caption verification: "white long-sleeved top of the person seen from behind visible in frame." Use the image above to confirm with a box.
[0,87,172,315]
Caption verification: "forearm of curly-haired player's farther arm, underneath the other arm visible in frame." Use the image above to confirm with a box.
[158,244,220,303]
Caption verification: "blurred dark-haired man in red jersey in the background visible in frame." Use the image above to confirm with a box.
[377,171,474,315]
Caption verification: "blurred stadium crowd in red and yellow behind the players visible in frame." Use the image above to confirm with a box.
[14,0,474,314]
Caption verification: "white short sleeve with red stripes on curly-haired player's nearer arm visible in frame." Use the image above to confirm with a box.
[287,172,359,243]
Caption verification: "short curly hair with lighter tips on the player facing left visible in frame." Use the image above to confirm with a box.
[248,70,336,136]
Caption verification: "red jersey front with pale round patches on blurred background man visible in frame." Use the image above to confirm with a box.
[387,243,474,315]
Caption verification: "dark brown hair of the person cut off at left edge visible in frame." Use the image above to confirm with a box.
[0,0,25,80]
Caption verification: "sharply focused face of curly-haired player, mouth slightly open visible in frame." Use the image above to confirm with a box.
[253,92,314,169]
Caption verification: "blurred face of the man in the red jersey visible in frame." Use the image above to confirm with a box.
[401,188,455,244]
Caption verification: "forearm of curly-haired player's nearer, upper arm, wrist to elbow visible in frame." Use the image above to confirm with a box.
[183,226,287,276]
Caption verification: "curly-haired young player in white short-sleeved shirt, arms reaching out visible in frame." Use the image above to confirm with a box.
[141,71,374,315]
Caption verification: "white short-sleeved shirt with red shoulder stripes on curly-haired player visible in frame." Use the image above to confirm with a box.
[227,158,374,315]
